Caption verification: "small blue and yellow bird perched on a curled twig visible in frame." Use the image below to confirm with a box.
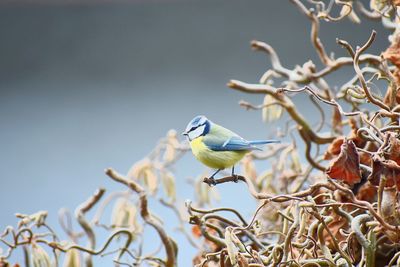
[182,115,280,185]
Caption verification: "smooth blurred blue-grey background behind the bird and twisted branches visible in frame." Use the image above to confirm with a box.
[0,0,388,266]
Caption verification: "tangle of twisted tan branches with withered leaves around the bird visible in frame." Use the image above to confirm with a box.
[0,0,400,267]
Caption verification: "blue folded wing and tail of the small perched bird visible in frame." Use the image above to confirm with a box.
[204,136,279,151]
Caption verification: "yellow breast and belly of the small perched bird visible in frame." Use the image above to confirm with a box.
[190,136,248,169]
